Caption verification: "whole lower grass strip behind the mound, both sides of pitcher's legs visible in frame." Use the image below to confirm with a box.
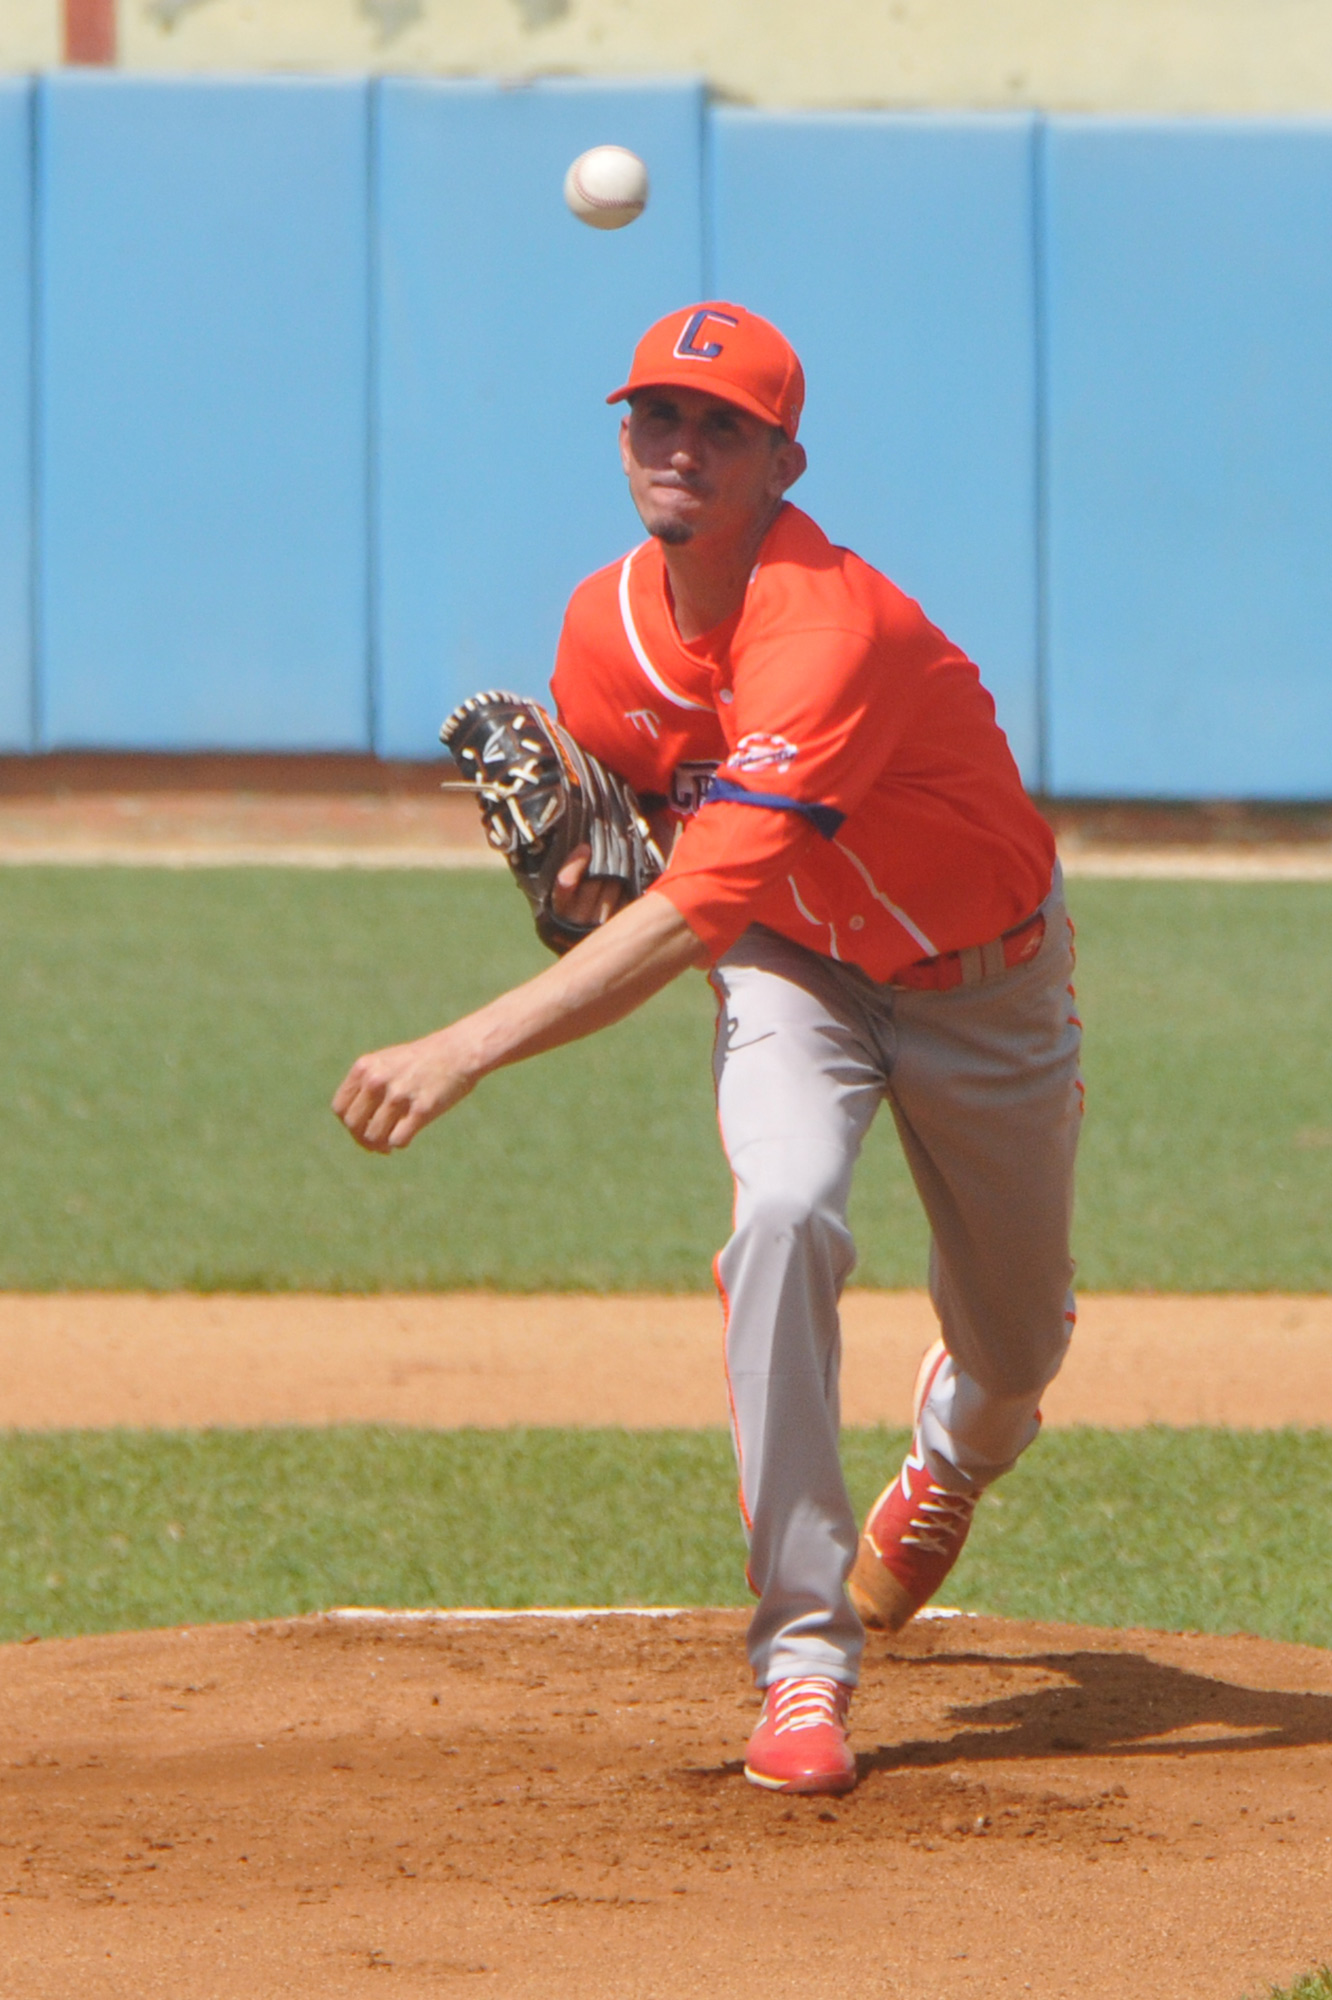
[0,1426,1332,1646]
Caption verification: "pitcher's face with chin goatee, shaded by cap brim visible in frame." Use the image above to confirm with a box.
[620,388,804,546]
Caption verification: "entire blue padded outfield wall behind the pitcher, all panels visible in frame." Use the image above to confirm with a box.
[0,72,1332,798]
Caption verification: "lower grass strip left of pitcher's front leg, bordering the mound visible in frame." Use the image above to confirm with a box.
[0,1426,744,1638]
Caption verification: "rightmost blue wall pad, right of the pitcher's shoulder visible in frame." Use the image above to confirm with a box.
[1044,118,1332,798]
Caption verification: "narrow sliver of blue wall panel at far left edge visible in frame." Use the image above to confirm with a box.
[0,78,32,752]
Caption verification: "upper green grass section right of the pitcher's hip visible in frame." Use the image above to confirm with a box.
[1070,882,1332,1292]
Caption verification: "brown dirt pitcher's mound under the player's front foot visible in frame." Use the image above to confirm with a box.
[0,1612,1332,2000]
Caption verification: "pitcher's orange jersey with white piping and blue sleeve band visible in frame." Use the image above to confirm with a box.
[552,504,1054,980]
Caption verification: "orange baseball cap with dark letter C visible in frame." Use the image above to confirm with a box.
[606,298,804,438]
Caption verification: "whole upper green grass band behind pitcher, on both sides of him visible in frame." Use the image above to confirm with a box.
[0,868,1332,1290]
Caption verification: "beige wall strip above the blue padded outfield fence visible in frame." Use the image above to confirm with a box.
[0,0,1332,114]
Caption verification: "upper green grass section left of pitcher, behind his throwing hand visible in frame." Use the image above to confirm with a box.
[0,868,730,1292]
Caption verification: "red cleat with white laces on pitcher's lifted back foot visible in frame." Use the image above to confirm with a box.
[846,1340,980,1632]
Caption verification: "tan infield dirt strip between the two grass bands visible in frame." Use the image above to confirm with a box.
[0,1290,1332,1430]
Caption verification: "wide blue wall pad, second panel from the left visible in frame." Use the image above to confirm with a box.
[38,72,370,750]
